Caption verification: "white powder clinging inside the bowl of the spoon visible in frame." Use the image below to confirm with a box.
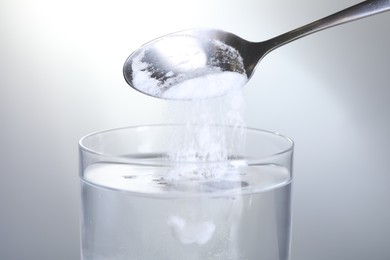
[132,36,248,100]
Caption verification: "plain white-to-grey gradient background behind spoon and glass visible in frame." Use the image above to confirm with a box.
[0,0,390,260]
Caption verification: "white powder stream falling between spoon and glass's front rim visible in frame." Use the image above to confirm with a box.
[169,89,245,167]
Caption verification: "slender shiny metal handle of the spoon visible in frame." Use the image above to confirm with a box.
[267,0,390,51]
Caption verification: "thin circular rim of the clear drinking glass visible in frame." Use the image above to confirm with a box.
[78,124,295,166]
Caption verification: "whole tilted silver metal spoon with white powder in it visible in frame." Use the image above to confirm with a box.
[123,0,390,100]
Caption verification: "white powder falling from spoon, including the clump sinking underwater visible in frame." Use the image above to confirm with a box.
[166,89,245,246]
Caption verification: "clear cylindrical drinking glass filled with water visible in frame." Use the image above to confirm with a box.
[79,125,293,260]
